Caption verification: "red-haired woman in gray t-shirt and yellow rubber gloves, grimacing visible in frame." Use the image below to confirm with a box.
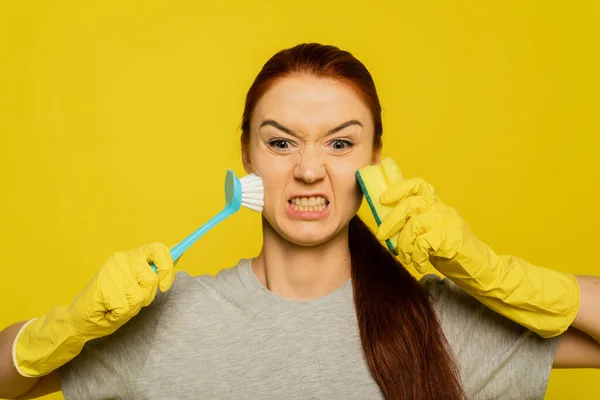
[0,44,600,399]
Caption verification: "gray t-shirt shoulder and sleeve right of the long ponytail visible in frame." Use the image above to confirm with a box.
[420,275,557,399]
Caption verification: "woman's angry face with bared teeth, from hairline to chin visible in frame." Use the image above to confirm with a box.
[244,76,379,246]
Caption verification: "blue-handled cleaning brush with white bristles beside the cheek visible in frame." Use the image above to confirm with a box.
[150,170,264,272]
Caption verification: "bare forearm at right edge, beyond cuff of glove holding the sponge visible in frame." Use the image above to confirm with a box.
[572,276,600,343]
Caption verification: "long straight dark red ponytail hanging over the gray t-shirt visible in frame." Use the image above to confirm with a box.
[349,216,465,400]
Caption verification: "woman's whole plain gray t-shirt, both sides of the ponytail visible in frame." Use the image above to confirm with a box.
[60,260,557,400]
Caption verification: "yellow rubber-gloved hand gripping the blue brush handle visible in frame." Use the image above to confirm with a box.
[13,243,175,377]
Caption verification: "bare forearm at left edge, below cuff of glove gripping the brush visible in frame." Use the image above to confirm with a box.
[0,322,38,399]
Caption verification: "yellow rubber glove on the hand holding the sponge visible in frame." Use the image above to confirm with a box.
[377,166,579,338]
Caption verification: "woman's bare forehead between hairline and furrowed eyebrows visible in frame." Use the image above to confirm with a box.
[252,76,372,129]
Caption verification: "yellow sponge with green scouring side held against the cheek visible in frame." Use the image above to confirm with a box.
[356,158,403,255]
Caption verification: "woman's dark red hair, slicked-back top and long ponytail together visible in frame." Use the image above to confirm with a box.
[241,43,464,400]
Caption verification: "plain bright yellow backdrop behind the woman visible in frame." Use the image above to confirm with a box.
[0,0,600,399]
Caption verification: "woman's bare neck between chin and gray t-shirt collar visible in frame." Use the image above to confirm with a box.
[252,217,351,300]
